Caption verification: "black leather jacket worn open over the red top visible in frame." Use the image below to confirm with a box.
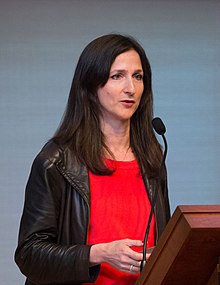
[15,142,170,285]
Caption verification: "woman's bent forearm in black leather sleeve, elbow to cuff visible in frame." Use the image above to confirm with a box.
[15,232,98,284]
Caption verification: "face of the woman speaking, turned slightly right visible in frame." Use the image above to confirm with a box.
[97,49,144,122]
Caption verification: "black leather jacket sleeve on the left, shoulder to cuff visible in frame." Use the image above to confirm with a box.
[15,150,99,284]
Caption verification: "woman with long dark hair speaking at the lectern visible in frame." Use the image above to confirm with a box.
[15,34,170,285]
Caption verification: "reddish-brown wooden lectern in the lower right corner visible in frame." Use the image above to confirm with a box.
[135,205,220,285]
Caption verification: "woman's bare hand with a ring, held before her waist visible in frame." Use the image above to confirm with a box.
[90,239,149,274]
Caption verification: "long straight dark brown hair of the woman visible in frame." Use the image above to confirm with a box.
[53,34,162,177]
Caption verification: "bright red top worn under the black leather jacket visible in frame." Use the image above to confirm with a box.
[84,160,155,285]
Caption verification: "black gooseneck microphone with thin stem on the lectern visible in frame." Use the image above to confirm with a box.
[140,117,168,271]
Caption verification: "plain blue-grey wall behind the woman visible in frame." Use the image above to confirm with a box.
[0,0,220,285]
